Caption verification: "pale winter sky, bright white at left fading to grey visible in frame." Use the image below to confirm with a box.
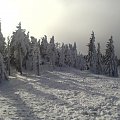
[0,0,120,57]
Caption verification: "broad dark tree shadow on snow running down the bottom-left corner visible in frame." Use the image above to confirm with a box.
[0,78,43,120]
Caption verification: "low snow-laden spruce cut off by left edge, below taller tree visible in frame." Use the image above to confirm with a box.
[0,53,8,82]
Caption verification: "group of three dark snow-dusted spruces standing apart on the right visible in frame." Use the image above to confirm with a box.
[87,32,118,77]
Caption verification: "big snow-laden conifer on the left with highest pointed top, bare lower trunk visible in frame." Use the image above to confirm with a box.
[10,23,28,74]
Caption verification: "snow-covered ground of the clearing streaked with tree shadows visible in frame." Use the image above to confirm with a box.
[0,68,120,120]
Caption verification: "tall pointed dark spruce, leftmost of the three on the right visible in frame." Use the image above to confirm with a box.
[88,32,97,73]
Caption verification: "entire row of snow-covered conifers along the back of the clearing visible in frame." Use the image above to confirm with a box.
[0,23,118,81]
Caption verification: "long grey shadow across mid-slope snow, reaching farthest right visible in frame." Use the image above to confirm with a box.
[24,71,106,97]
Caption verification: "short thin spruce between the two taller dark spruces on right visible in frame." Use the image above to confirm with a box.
[96,43,103,74]
